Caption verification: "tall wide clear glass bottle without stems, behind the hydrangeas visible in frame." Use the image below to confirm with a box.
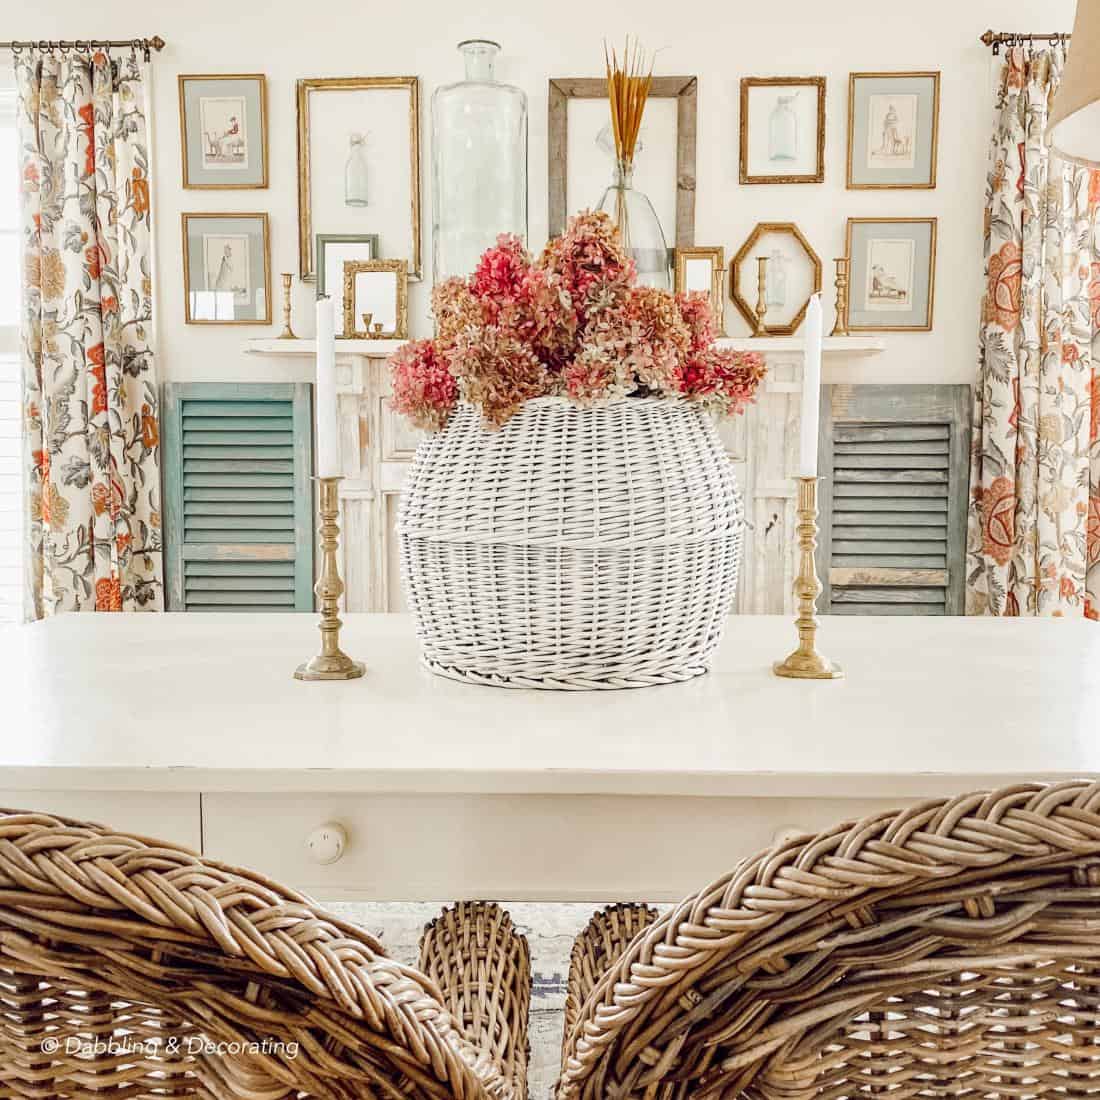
[431,39,527,283]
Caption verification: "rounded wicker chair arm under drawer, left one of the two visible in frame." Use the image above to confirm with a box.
[420,901,531,1100]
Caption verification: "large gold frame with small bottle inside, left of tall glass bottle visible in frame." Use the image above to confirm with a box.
[297,76,421,279]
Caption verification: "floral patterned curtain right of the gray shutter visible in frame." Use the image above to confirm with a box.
[967,47,1100,619]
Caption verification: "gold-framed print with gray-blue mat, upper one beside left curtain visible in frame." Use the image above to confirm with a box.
[179,73,267,190]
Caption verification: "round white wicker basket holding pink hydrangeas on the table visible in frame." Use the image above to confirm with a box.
[397,397,744,690]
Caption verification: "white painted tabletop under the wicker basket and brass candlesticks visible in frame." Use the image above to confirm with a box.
[0,614,1100,798]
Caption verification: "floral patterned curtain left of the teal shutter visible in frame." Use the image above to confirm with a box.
[15,51,164,618]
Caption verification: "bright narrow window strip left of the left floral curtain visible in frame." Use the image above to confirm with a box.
[0,88,23,628]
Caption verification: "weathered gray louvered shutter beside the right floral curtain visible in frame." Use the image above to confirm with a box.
[817,385,970,615]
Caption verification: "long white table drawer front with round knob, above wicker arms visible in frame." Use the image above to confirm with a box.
[202,794,897,902]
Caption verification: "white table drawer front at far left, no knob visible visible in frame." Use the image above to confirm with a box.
[0,790,202,851]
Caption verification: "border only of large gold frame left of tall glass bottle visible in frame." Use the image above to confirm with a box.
[297,76,422,282]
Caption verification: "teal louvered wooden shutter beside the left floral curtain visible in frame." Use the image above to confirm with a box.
[163,383,314,612]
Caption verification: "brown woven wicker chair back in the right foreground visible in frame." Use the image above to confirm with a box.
[558,781,1100,1100]
